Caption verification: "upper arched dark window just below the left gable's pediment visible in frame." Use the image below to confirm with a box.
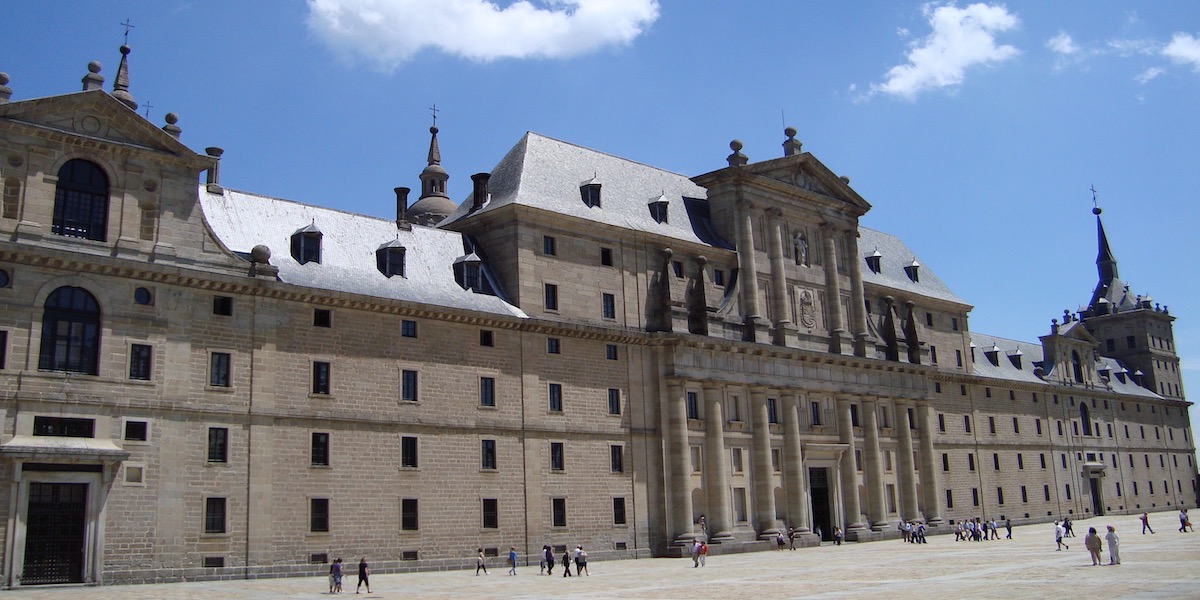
[50,158,108,241]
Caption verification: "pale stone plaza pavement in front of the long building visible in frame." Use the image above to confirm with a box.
[9,512,1200,600]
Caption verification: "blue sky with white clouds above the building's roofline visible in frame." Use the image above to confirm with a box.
[0,0,1200,422]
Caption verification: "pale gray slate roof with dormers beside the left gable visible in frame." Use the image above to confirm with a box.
[199,185,526,318]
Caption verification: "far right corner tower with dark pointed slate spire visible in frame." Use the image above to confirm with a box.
[1080,206,1183,400]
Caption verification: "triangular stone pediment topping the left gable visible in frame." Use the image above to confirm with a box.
[0,90,208,164]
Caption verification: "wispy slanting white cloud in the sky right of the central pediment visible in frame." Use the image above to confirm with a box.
[871,4,1018,100]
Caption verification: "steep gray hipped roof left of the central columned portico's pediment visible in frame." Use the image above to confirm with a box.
[444,132,732,248]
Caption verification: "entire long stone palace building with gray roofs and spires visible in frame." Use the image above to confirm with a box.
[0,47,1196,587]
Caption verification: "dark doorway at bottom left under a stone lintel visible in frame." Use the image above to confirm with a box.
[20,481,88,586]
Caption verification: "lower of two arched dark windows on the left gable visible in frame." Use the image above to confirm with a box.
[37,287,100,374]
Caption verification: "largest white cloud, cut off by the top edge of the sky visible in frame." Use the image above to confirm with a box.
[308,0,659,70]
